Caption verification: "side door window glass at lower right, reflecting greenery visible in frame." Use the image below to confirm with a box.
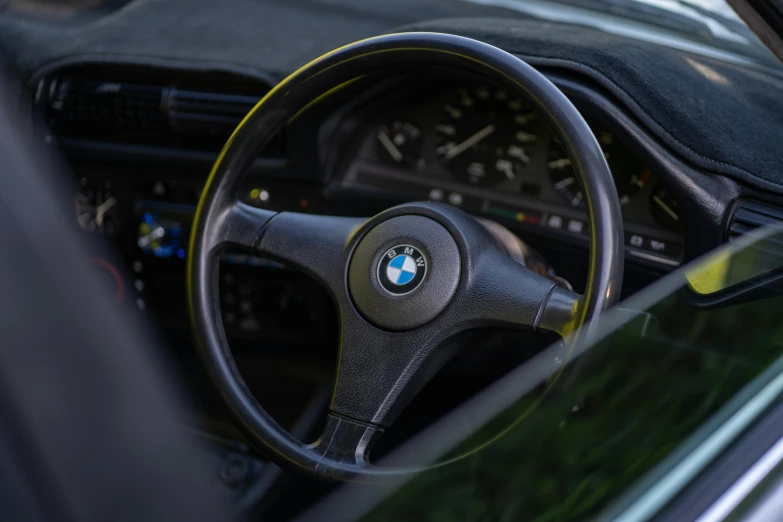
[308,226,783,521]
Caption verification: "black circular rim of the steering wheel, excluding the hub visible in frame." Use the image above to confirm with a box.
[187,33,623,478]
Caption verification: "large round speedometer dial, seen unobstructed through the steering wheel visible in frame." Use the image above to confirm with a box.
[435,86,538,186]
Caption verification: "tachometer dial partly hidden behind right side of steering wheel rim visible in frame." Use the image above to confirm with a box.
[547,130,651,208]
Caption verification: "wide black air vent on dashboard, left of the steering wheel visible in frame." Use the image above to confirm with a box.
[36,71,285,158]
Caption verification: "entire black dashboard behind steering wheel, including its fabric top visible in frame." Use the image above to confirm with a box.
[9,0,783,330]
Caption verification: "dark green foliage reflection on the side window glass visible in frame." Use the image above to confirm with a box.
[336,226,783,521]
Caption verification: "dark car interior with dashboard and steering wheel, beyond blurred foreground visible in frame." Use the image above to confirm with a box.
[0,0,783,520]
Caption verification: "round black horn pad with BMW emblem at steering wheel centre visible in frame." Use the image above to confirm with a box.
[348,215,462,331]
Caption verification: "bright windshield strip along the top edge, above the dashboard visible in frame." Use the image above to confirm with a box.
[0,0,780,68]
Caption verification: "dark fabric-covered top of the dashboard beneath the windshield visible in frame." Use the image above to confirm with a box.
[0,0,783,193]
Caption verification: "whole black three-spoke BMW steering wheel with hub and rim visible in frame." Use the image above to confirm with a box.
[187,33,623,479]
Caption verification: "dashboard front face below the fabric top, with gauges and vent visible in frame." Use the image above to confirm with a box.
[34,66,685,346]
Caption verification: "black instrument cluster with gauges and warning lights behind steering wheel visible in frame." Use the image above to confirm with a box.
[337,82,682,266]
